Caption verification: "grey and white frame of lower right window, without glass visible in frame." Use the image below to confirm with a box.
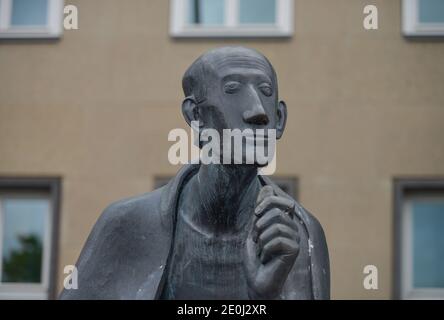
[393,177,444,299]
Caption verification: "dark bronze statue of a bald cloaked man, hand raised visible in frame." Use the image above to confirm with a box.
[61,47,330,299]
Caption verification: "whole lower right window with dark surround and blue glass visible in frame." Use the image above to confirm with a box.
[395,180,444,299]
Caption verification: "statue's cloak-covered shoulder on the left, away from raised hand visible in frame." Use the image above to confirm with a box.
[60,188,169,299]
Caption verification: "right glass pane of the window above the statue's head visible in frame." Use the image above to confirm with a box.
[239,0,276,23]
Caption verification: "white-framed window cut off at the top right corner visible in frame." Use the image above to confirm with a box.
[402,0,444,36]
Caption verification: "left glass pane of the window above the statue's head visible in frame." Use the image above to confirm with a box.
[188,0,225,25]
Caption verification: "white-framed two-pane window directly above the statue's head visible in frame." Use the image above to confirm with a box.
[170,0,293,37]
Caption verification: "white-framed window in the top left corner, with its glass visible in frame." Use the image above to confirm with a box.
[0,0,63,38]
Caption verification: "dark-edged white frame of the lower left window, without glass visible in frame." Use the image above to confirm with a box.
[0,177,61,299]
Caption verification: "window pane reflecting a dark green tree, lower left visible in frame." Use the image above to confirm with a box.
[1,198,49,283]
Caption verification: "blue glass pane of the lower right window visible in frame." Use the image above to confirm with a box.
[412,201,444,288]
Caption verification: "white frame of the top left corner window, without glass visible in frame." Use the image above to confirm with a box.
[0,0,64,39]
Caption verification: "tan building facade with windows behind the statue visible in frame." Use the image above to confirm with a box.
[0,0,444,299]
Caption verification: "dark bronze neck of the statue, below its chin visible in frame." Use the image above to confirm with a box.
[189,164,260,234]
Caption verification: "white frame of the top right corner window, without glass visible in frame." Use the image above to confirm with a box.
[402,0,444,36]
